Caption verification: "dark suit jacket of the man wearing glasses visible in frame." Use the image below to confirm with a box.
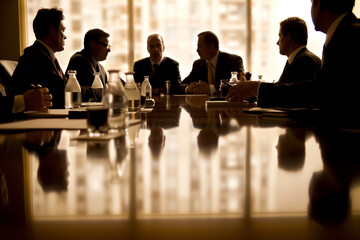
[66,49,107,102]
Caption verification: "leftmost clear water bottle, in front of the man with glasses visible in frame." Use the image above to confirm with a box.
[65,70,81,109]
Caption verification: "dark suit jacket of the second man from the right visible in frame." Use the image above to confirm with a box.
[278,48,321,83]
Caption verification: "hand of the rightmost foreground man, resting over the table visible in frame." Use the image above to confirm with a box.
[225,81,260,102]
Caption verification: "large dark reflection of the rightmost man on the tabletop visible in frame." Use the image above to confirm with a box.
[308,129,360,225]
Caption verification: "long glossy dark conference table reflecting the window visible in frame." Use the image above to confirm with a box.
[0,95,360,240]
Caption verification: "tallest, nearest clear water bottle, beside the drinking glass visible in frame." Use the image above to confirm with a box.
[104,70,128,131]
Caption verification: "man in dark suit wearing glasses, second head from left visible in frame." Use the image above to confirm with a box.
[66,28,111,102]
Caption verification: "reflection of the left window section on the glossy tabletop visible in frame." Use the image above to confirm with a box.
[26,131,129,219]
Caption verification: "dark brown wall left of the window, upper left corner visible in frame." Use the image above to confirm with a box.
[0,0,20,61]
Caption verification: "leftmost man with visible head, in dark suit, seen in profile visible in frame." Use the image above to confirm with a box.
[11,8,66,108]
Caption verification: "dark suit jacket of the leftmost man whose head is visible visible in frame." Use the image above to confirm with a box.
[11,41,66,108]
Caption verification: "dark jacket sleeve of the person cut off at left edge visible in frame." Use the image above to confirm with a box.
[0,64,14,122]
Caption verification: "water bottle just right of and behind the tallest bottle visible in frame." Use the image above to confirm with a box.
[125,72,141,111]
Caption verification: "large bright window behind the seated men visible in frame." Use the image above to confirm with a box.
[27,0,346,82]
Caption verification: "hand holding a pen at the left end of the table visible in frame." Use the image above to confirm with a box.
[24,88,52,112]
